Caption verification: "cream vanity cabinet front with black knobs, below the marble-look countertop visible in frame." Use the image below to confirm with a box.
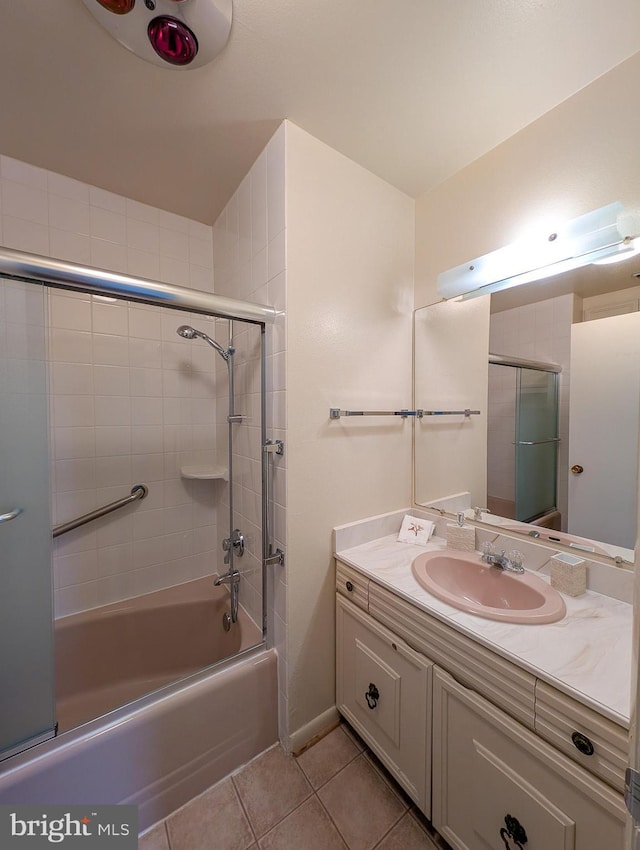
[336,562,627,850]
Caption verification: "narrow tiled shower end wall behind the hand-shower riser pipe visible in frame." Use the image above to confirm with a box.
[213,124,287,735]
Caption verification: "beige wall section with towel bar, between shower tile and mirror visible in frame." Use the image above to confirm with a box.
[286,123,414,744]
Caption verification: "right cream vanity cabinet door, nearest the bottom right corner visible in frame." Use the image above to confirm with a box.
[433,668,625,850]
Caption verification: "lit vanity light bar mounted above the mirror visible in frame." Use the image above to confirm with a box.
[438,201,638,300]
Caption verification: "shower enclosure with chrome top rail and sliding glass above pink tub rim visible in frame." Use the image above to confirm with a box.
[0,245,277,763]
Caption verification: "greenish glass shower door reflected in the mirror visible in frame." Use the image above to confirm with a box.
[515,368,558,522]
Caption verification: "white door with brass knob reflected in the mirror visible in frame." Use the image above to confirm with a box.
[561,313,640,549]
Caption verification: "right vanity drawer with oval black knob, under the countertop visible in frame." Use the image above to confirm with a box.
[535,681,629,791]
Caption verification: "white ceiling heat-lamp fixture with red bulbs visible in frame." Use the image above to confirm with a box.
[83,0,233,69]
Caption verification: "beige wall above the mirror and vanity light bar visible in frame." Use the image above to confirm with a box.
[415,53,640,512]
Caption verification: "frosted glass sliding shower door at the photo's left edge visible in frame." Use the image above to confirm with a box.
[0,281,55,760]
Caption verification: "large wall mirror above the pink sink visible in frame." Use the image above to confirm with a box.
[414,247,640,563]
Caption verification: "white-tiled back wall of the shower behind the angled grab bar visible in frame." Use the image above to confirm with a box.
[0,156,226,616]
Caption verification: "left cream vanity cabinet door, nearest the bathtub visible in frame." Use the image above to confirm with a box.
[336,596,433,815]
